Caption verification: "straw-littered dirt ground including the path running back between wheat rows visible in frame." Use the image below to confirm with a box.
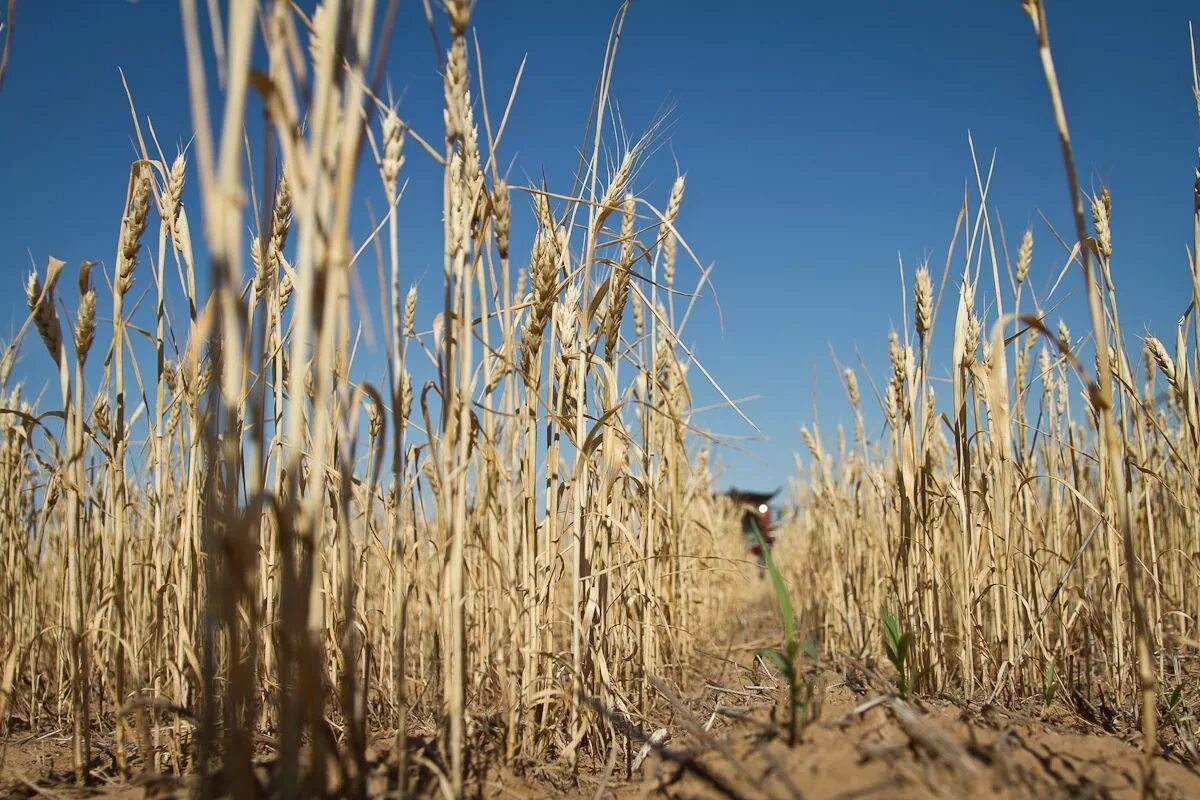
[0,585,1200,800]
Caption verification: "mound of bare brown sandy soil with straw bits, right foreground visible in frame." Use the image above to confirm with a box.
[549,686,1200,800]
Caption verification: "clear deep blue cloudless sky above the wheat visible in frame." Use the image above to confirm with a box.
[0,0,1198,487]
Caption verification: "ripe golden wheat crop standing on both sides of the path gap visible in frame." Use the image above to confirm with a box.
[0,0,1200,798]
